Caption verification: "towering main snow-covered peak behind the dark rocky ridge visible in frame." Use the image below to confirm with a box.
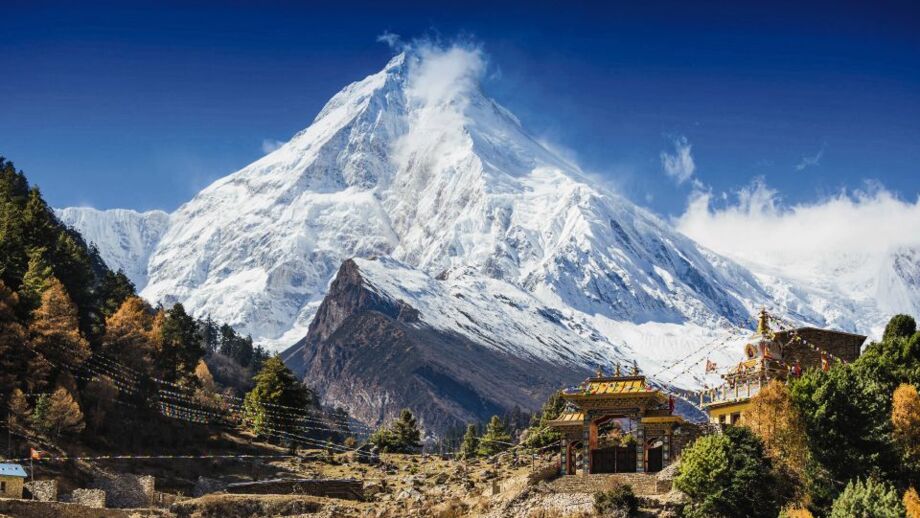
[129,49,764,350]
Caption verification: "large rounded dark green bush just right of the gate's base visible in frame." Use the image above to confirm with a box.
[674,427,779,518]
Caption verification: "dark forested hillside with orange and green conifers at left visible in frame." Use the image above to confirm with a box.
[0,157,345,451]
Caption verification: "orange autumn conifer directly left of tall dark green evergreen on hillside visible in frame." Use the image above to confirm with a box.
[102,295,157,373]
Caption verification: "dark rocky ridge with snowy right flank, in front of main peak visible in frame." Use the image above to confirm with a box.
[287,258,604,431]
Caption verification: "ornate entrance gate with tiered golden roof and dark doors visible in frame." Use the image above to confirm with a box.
[549,367,698,475]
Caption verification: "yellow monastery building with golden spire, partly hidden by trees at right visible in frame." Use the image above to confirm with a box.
[700,310,866,425]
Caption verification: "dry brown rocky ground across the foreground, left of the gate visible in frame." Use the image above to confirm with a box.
[18,438,680,518]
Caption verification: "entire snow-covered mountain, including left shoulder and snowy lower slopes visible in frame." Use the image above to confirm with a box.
[62,47,918,400]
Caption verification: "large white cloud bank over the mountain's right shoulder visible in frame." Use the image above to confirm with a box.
[675,179,920,282]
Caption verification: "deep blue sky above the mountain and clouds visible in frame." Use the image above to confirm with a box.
[0,0,920,215]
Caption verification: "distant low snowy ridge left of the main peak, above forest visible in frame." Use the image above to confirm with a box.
[55,207,169,289]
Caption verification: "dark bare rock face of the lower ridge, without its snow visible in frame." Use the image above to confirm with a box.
[287,260,588,432]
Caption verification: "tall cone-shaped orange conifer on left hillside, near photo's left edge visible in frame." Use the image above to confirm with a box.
[29,277,90,366]
